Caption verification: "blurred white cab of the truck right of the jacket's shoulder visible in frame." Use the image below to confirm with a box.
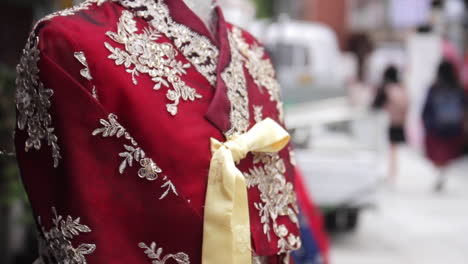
[263,19,344,104]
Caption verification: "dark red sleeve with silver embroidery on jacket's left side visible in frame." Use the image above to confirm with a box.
[15,23,112,263]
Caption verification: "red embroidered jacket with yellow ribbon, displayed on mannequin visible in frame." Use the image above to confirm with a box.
[15,0,301,264]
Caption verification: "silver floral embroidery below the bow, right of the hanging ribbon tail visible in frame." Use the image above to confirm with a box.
[244,153,301,253]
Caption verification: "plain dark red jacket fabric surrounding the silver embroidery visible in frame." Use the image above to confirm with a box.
[15,1,298,264]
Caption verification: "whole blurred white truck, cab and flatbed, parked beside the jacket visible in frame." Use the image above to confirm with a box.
[263,21,387,230]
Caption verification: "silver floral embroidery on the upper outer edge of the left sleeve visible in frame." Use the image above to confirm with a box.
[16,35,62,168]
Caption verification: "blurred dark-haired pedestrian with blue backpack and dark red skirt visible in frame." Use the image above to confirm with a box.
[423,60,467,191]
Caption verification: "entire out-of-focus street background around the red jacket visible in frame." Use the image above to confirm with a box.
[0,0,468,264]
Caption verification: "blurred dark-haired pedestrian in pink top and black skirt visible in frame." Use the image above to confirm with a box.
[373,66,409,181]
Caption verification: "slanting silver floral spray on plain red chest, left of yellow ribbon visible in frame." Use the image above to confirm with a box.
[92,114,179,200]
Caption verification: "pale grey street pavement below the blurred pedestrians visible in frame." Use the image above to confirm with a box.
[331,147,468,264]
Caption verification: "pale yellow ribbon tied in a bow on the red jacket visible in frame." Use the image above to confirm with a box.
[202,118,290,264]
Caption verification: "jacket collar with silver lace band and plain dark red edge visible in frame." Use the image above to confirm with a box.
[115,0,231,135]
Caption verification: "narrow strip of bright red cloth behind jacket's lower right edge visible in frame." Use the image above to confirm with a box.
[294,167,330,264]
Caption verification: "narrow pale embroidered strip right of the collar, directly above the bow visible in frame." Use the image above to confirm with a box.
[221,32,250,137]
